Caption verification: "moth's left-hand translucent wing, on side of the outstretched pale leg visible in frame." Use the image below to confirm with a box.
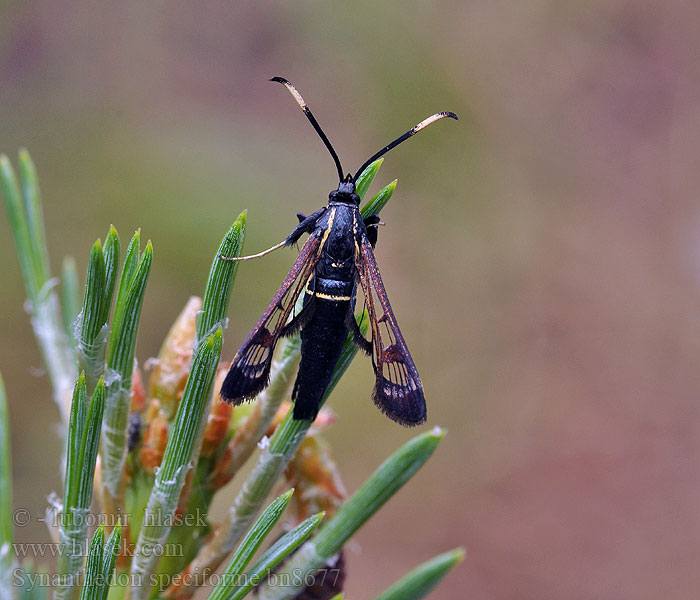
[221,235,320,404]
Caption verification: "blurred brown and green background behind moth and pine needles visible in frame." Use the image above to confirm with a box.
[0,0,700,600]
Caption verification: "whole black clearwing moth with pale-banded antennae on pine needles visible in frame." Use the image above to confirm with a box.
[221,77,457,426]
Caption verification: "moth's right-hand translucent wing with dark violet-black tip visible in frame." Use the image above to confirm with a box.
[356,235,426,427]
